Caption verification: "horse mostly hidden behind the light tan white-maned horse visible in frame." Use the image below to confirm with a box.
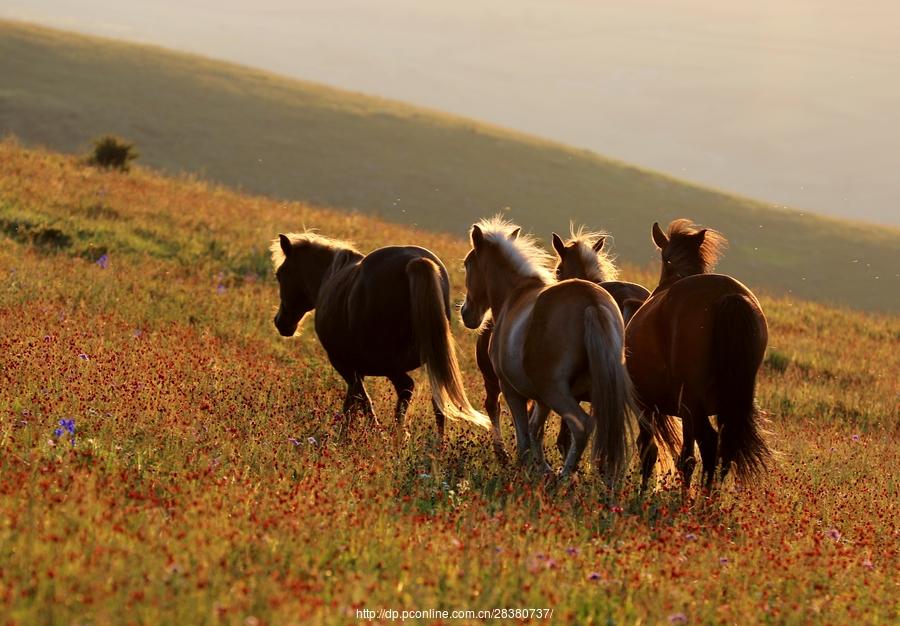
[475,225,650,462]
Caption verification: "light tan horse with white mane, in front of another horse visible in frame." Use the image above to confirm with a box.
[462,217,631,486]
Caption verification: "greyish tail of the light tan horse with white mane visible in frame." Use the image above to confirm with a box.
[584,306,635,488]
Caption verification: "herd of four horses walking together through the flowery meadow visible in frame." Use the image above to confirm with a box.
[271,217,770,489]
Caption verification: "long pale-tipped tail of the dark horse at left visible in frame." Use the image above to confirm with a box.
[406,258,491,428]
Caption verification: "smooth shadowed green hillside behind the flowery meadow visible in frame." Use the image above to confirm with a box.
[0,22,900,312]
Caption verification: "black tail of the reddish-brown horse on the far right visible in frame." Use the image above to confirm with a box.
[713,294,771,480]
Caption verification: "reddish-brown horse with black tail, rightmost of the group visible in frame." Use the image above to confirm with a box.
[626,219,770,490]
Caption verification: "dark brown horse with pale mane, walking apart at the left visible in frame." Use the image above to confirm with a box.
[271,232,490,436]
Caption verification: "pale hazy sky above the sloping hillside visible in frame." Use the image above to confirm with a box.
[0,0,900,224]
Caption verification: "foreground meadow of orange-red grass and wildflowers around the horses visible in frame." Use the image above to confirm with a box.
[0,140,900,625]
